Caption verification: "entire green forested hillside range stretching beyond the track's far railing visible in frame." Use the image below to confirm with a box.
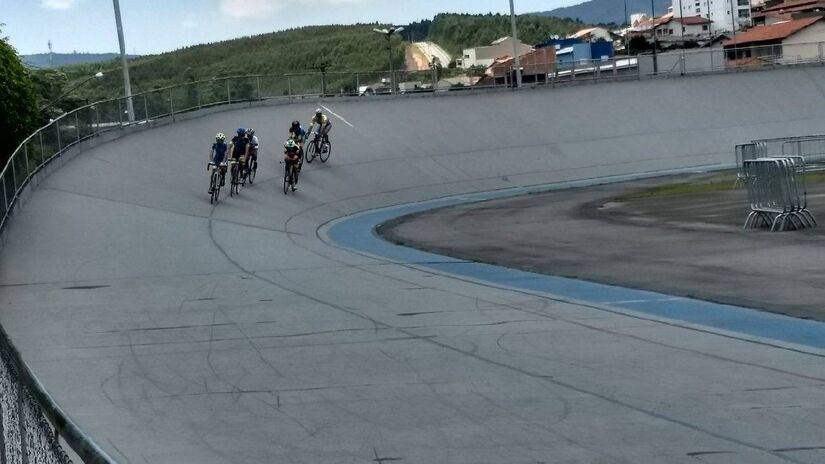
[34,14,584,113]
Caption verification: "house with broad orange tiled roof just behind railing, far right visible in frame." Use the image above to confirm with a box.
[723,16,825,66]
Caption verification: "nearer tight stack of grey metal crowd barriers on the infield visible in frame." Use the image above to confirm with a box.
[743,156,816,231]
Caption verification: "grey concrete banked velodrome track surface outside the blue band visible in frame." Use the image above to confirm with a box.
[0,68,825,464]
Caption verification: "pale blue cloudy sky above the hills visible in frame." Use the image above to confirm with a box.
[0,0,583,55]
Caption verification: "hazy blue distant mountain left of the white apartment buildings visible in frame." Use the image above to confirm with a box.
[534,0,671,24]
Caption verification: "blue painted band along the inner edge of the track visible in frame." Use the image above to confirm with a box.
[327,168,825,349]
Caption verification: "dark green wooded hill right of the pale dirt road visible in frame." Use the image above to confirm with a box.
[430,14,586,55]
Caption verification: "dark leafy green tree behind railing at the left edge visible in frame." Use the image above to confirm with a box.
[0,26,39,169]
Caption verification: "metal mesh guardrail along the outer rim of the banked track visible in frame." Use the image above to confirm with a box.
[0,40,825,464]
